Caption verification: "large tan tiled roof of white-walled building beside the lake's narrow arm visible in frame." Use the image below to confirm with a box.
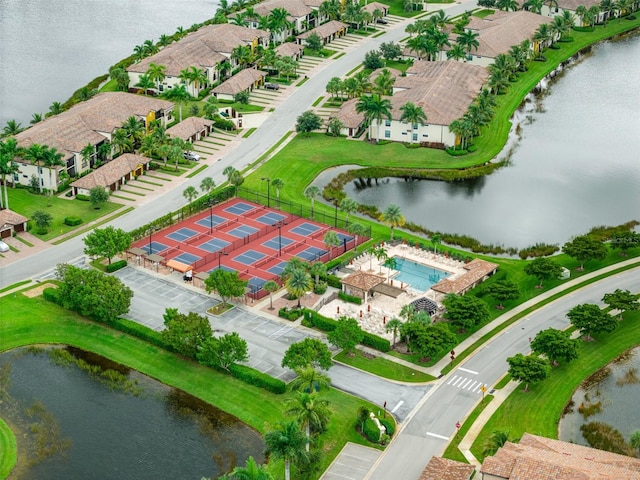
[389,60,489,125]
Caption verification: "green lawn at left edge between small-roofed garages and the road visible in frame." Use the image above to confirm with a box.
[9,188,122,240]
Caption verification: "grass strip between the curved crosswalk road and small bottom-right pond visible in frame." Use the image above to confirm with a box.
[471,312,640,460]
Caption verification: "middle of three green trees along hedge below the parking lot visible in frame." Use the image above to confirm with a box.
[162,308,213,359]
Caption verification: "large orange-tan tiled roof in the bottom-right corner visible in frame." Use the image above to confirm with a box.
[480,433,640,480]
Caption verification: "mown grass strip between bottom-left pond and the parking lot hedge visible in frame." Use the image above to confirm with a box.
[0,294,388,480]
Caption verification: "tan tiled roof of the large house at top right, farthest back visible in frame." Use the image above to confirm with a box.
[451,10,553,58]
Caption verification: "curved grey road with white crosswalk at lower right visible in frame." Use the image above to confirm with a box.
[366,268,640,480]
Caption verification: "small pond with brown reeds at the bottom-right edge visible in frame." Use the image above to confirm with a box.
[559,347,640,445]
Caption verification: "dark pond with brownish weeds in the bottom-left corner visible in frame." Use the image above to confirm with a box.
[0,349,264,480]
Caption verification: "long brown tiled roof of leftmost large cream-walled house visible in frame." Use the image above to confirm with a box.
[16,92,174,156]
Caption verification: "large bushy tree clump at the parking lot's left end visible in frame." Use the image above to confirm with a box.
[56,264,133,322]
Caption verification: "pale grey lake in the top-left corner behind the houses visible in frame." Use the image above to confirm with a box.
[0,0,218,127]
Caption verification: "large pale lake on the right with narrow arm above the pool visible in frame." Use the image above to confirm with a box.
[346,35,640,247]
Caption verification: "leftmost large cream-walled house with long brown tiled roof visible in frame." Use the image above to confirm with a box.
[14,92,174,190]
